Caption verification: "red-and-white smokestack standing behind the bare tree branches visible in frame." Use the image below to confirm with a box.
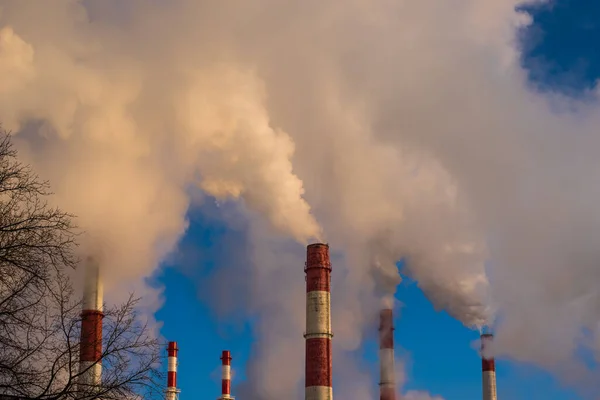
[79,260,104,386]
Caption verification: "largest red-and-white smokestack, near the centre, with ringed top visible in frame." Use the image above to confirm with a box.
[304,243,333,400]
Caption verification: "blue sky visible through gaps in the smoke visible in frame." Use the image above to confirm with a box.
[155,0,600,400]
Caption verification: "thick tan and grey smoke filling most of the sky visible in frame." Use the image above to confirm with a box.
[0,0,600,398]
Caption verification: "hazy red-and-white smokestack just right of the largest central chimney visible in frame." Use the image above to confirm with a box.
[379,308,396,400]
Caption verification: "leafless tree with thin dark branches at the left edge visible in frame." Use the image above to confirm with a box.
[0,127,163,400]
